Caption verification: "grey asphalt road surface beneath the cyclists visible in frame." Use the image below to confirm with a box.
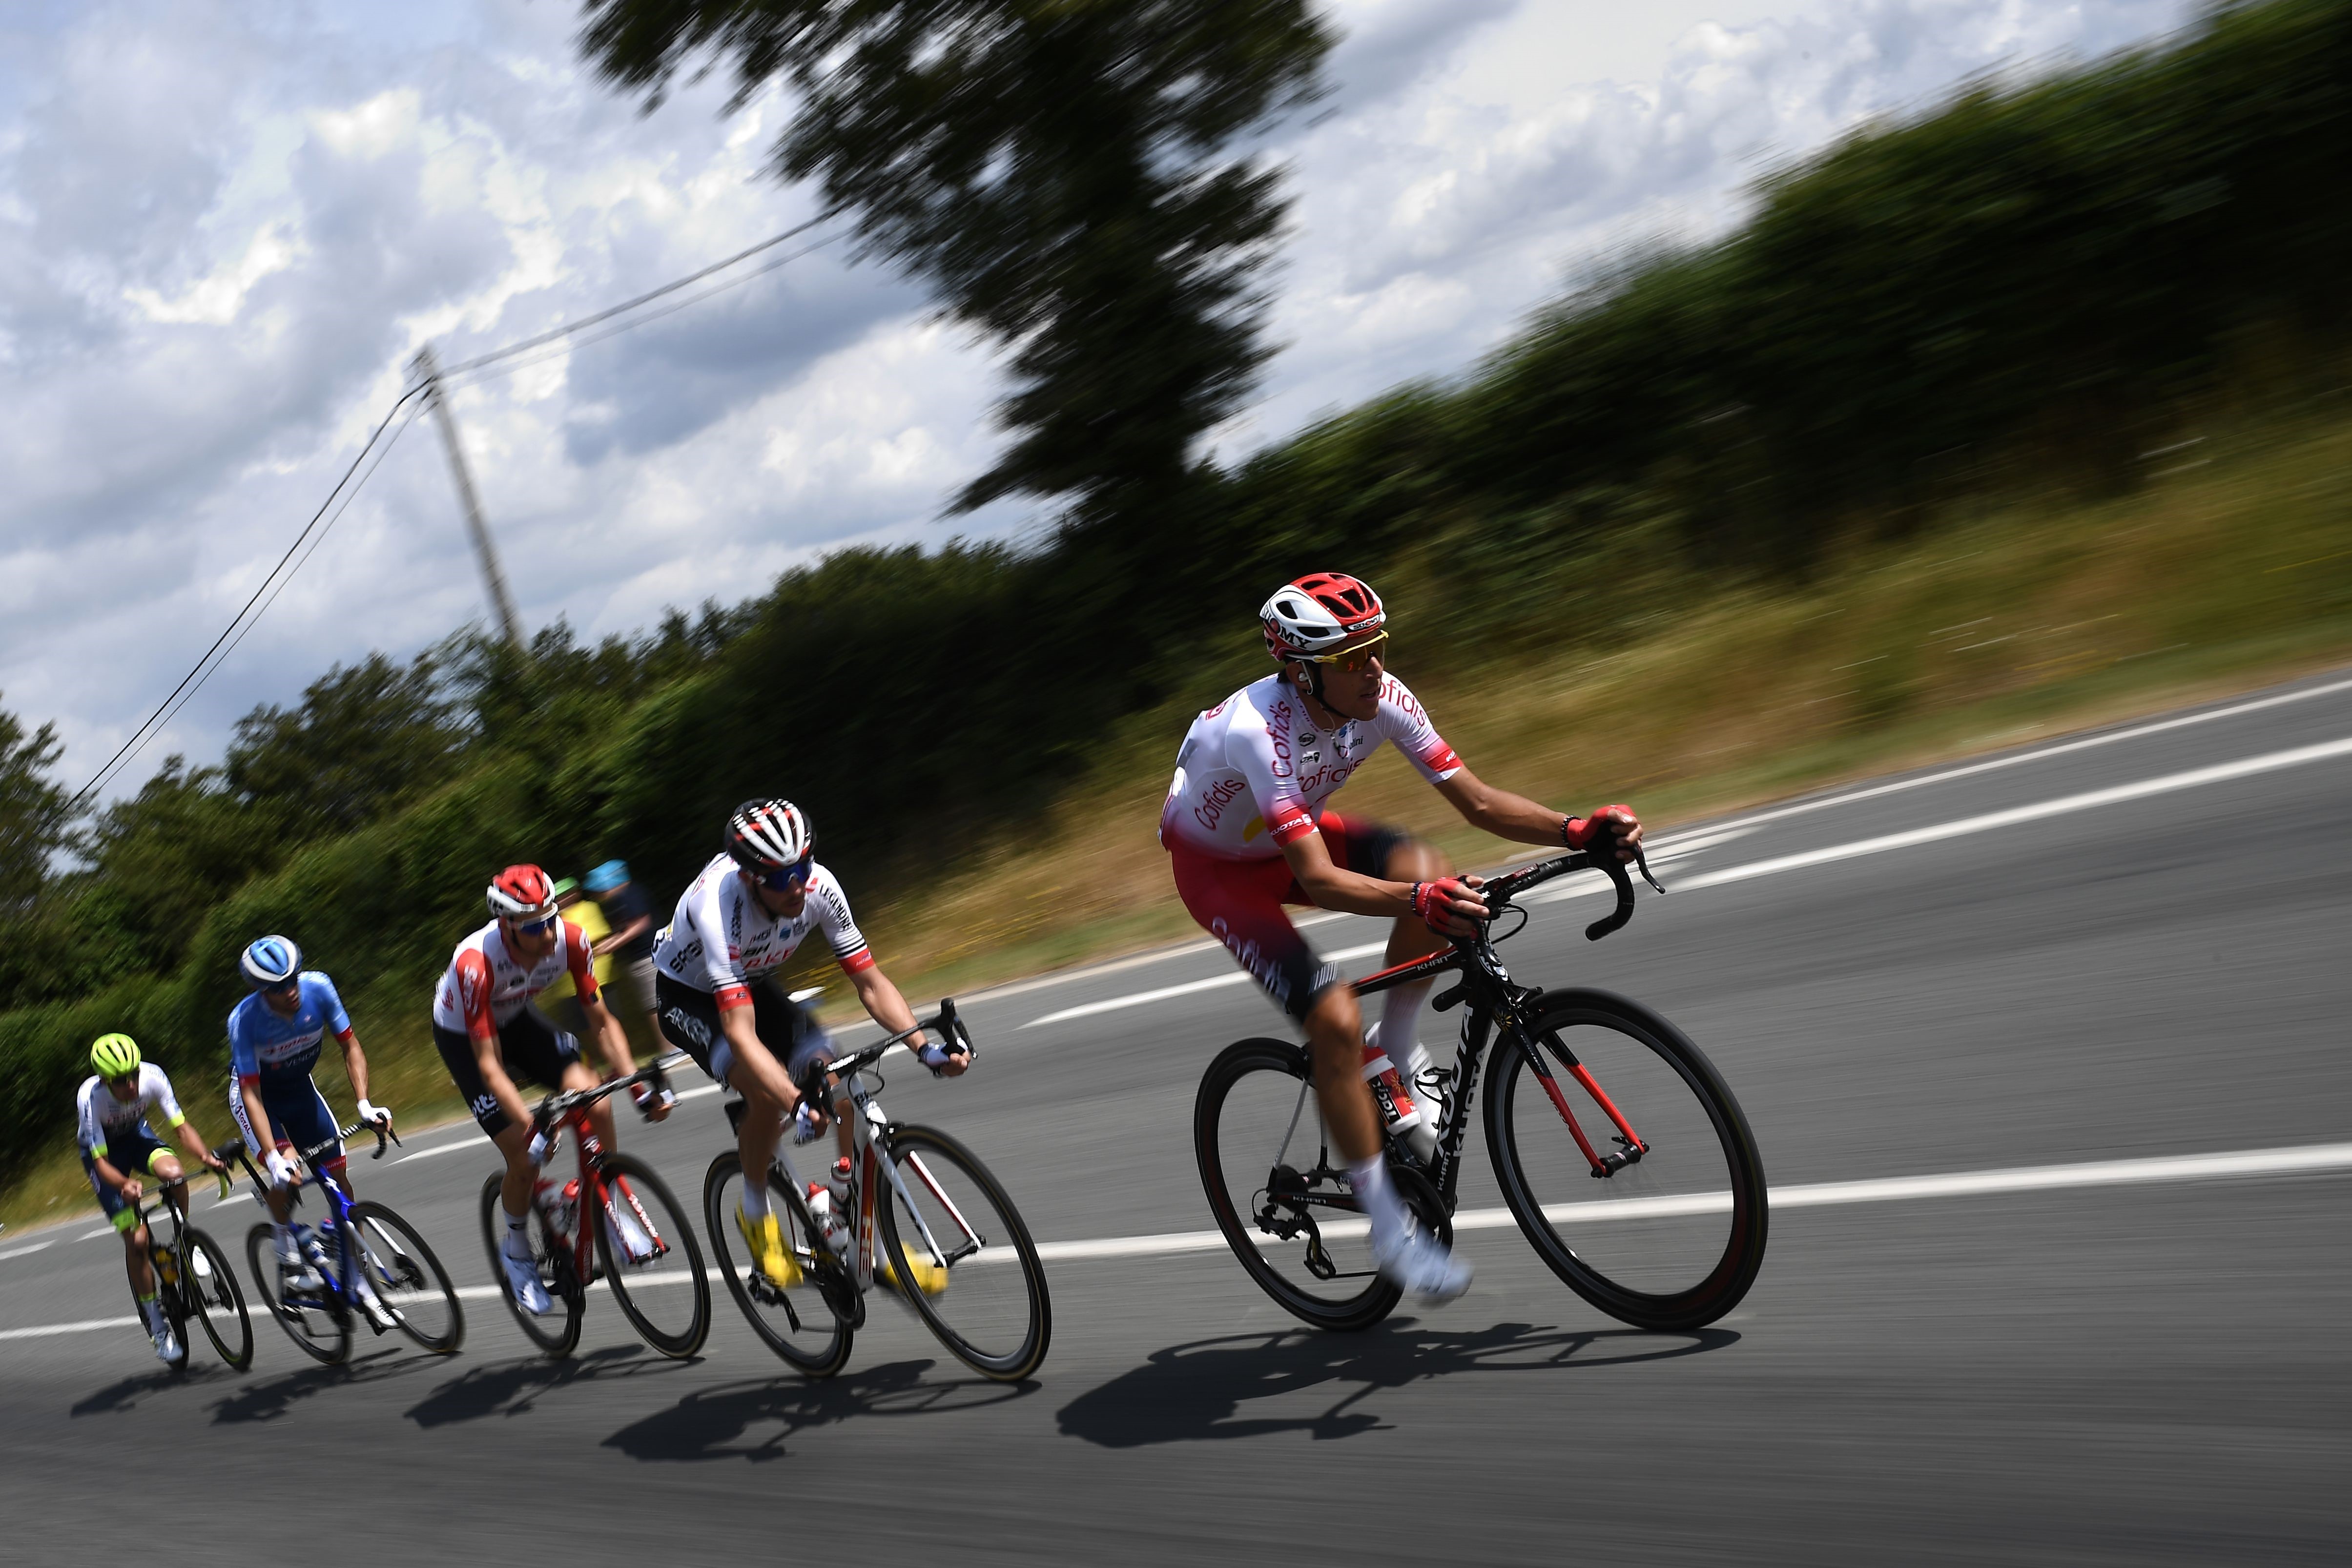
[0,682,2352,1563]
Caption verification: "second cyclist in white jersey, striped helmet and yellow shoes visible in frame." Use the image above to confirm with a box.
[654,799,971,1295]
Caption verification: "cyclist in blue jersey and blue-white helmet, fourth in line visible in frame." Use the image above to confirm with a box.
[228,936,393,1333]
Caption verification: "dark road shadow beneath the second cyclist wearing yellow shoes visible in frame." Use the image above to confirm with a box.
[604,1361,1037,1462]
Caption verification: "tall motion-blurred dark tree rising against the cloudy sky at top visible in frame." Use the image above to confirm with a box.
[581,0,1331,522]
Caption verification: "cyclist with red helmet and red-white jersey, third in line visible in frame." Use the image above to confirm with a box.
[433,865,670,1314]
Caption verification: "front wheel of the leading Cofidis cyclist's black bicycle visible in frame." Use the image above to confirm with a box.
[1486,990,1766,1331]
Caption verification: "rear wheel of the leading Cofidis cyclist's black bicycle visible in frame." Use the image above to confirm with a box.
[1193,1039,1411,1328]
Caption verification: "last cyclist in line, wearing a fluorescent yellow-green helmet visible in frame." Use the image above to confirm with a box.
[75,1034,221,1366]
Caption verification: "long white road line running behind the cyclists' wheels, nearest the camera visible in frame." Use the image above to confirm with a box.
[0,1142,2352,1340]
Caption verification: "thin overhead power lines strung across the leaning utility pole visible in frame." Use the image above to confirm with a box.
[66,219,837,813]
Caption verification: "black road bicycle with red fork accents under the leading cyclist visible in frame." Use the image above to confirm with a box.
[1193,848,1766,1331]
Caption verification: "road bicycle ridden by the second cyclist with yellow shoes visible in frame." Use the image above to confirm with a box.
[703,999,1053,1382]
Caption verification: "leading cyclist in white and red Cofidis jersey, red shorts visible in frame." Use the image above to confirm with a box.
[1159,571,1642,1300]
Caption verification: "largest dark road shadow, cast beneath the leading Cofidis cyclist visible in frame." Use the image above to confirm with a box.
[1058,1321,1740,1448]
